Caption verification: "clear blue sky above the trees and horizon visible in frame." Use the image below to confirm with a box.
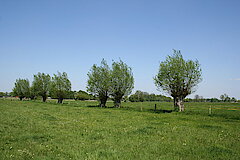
[0,0,240,99]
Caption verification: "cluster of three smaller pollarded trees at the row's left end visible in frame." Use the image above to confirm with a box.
[13,72,71,103]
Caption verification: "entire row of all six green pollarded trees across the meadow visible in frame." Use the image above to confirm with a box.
[11,50,202,112]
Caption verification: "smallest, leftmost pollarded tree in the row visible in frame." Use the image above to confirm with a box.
[13,78,30,100]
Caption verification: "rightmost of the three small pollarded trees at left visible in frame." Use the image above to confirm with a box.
[50,72,71,103]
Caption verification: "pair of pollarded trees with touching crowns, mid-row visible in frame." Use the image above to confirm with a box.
[87,59,134,107]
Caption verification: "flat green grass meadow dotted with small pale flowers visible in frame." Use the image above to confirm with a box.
[0,99,240,160]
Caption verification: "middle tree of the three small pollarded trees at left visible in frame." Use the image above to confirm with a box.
[32,72,51,102]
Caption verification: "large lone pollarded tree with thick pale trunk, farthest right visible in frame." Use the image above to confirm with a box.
[154,50,202,112]
